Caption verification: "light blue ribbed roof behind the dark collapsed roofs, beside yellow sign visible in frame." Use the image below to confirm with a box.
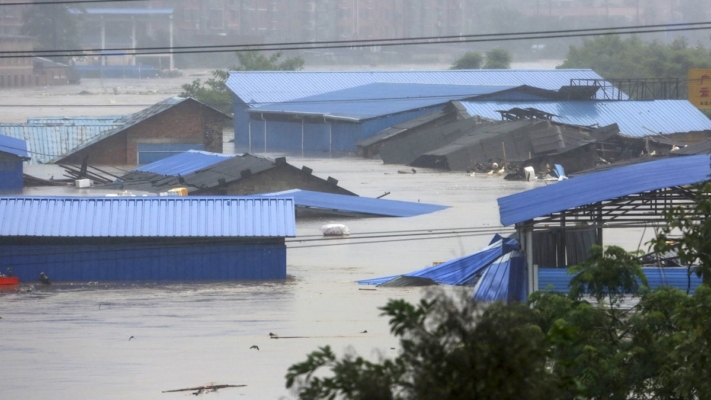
[461,100,711,137]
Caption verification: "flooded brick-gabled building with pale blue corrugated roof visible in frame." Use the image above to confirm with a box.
[0,97,230,165]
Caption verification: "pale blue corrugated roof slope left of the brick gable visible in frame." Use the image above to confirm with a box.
[0,123,121,164]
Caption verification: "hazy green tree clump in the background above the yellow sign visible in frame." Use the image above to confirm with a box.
[558,36,711,79]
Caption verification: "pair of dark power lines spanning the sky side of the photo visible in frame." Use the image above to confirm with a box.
[0,22,711,58]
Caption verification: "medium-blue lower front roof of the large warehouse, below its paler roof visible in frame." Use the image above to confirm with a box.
[249,83,514,120]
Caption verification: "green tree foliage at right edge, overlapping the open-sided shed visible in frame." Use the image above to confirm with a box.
[651,181,711,285]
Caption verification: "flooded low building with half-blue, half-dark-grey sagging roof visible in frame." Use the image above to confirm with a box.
[100,150,355,196]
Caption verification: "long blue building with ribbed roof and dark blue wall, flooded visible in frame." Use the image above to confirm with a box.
[0,197,296,282]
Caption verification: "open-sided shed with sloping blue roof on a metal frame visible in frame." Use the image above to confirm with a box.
[498,155,711,293]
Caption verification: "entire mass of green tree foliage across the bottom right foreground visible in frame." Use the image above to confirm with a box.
[286,246,711,400]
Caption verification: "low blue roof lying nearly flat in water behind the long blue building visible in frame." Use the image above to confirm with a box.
[259,189,449,217]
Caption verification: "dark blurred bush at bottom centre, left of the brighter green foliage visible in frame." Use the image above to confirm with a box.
[286,293,559,400]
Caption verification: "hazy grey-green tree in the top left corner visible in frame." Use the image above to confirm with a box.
[20,1,83,63]
